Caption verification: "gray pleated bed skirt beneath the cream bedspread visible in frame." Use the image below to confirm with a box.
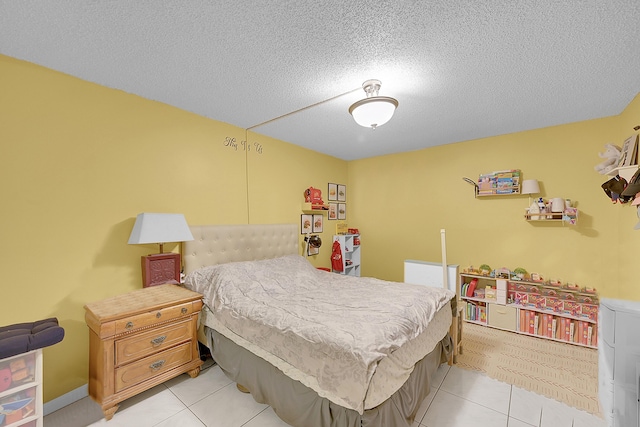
[206,328,453,427]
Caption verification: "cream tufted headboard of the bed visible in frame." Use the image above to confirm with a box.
[182,224,301,273]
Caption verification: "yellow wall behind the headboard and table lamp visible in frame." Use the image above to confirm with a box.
[0,56,347,401]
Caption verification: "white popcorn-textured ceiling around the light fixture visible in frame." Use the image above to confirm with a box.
[0,0,640,160]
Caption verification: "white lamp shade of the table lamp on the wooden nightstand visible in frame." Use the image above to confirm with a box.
[129,213,193,245]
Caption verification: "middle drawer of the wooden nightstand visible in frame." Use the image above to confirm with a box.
[115,317,195,366]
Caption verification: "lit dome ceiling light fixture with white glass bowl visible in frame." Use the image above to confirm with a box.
[349,80,398,129]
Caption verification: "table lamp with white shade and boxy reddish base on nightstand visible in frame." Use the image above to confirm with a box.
[128,213,193,288]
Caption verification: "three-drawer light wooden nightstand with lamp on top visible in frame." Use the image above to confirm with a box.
[84,285,202,420]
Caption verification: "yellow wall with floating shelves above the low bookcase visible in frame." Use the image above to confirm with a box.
[349,98,640,300]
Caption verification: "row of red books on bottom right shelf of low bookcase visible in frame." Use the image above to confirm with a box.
[516,309,598,347]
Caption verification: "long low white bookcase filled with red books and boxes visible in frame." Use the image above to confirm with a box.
[460,271,598,348]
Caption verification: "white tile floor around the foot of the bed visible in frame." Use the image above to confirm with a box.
[44,363,605,427]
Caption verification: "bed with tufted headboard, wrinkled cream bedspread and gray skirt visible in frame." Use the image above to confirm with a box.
[183,224,456,427]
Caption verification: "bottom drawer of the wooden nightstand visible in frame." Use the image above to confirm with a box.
[115,342,192,392]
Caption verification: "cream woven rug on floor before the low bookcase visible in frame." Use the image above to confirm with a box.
[456,323,600,414]
